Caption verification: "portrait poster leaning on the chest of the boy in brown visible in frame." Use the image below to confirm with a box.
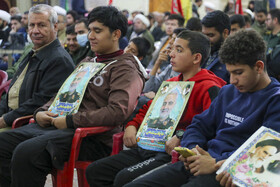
[49,62,105,116]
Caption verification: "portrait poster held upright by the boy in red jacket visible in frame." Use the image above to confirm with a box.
[136,81,194,152]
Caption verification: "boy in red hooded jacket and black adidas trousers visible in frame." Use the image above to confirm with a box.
[86,31,226,186]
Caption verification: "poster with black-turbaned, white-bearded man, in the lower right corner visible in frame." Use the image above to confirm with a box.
[217,127,280,187]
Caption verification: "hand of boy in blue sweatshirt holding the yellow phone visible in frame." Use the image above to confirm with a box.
[187,145,216,176]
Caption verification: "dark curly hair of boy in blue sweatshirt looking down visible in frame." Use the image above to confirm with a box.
[219,29,266,70]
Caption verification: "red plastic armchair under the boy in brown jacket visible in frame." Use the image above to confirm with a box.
[12,116,123,187]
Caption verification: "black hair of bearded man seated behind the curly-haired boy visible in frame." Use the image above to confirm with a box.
[201,10,230,34]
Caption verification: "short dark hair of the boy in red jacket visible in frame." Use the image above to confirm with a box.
[177,30,211,64]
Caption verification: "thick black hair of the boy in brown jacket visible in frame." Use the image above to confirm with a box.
[88,6,128,38]
